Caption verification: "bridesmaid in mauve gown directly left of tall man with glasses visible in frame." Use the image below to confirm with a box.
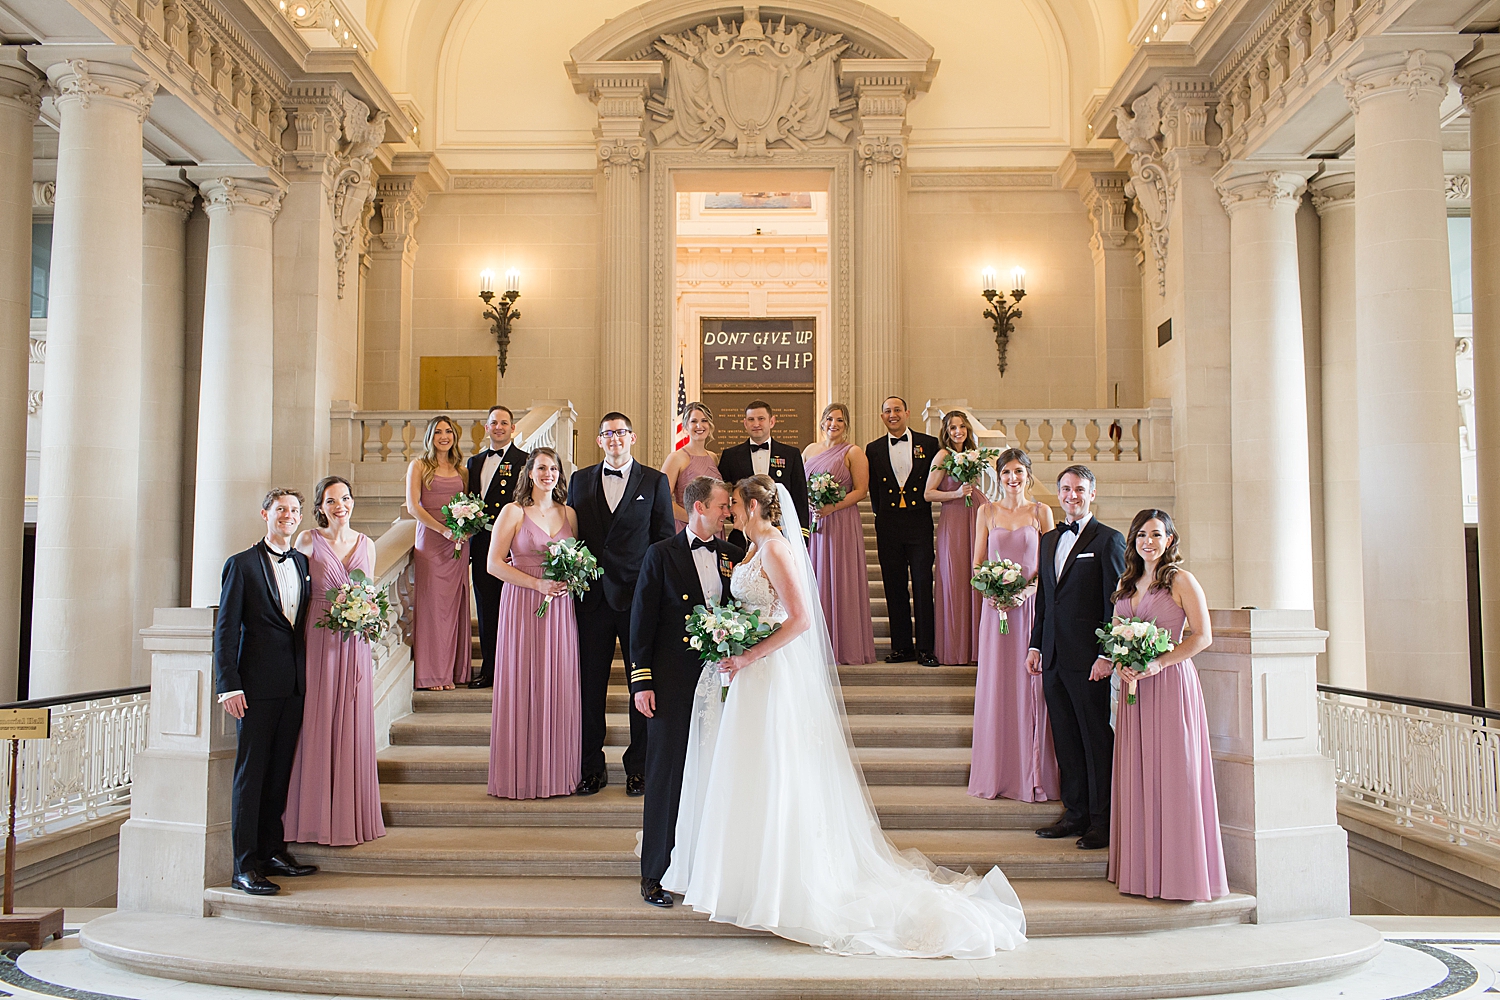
[486,448,584,799]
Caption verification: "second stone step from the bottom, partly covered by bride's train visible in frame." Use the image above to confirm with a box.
[204,873,1256,939]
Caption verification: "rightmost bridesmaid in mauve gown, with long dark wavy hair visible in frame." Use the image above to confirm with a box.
[1106,510,1229,901]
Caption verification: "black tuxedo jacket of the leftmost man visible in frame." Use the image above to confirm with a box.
[213,541,312,702]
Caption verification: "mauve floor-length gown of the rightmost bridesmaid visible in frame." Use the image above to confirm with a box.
[1109,588,1229,901]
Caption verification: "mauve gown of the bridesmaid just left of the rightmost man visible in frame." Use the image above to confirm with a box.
[969,525,1061,802]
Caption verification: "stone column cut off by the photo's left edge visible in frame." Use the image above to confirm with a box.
[0,45,41,702]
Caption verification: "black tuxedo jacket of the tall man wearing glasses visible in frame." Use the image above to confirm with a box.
[567,460,677,612]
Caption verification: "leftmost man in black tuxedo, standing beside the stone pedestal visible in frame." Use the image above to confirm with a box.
[213,489,317,895]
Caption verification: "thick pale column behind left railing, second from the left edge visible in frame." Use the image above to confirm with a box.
[30,48,156,697]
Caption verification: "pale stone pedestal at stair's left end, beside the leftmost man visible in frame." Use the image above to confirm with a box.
[119,607,236,916]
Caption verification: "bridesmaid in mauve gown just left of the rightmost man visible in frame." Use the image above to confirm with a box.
[969,448,1061,802]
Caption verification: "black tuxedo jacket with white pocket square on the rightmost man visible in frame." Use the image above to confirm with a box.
[1031,517,1125,672]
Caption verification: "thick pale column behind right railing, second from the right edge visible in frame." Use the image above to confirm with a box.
[1344,49,1470,703]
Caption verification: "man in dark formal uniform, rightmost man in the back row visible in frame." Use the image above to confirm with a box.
[864,396,938,667]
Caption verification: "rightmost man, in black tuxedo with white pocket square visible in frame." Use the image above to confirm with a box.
[1026,465,1125,850]
